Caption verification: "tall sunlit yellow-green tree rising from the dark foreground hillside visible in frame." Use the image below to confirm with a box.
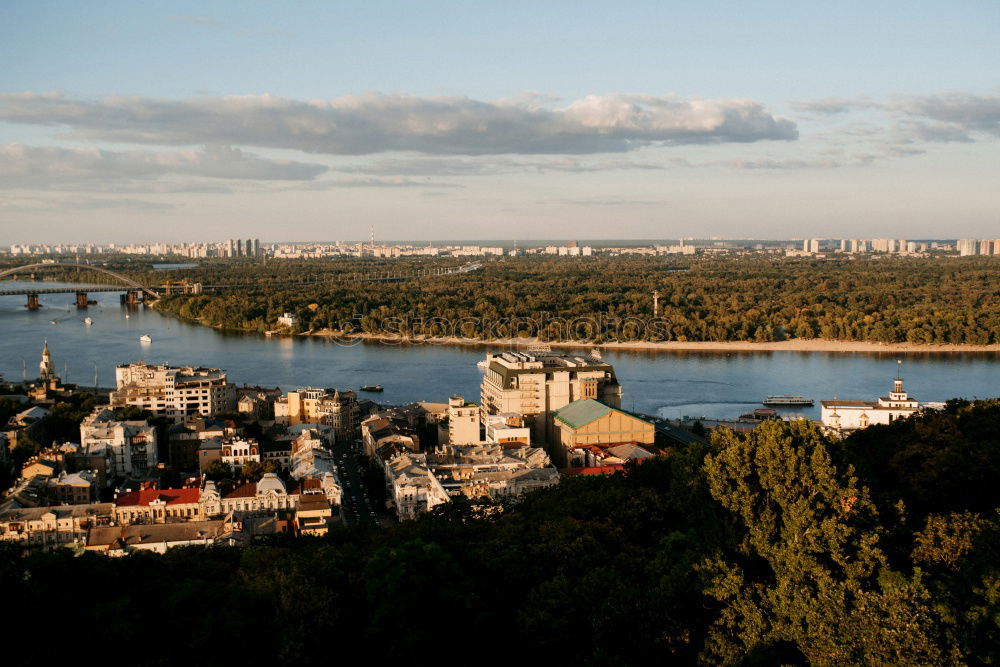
[703,421,950,665]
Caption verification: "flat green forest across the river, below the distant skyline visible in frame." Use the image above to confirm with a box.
[1,256,1000,345]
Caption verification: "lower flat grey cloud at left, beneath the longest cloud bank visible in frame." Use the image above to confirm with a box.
[0,145,327,192]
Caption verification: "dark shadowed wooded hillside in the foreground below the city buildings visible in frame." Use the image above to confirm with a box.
[0,401,1000,665]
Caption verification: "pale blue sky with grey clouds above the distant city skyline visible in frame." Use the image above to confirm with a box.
[0,0,1000,245]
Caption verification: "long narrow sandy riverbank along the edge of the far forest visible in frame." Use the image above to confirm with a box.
[301,329,1000,354]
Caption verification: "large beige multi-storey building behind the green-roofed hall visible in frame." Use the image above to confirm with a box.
[480,352,622,442]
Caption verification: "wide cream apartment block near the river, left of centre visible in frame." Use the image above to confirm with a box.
[111,362,236,421]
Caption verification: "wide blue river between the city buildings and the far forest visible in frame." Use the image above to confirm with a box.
[0,281,1000,419]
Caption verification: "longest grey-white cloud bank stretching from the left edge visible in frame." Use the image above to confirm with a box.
[0,93,798,155]
